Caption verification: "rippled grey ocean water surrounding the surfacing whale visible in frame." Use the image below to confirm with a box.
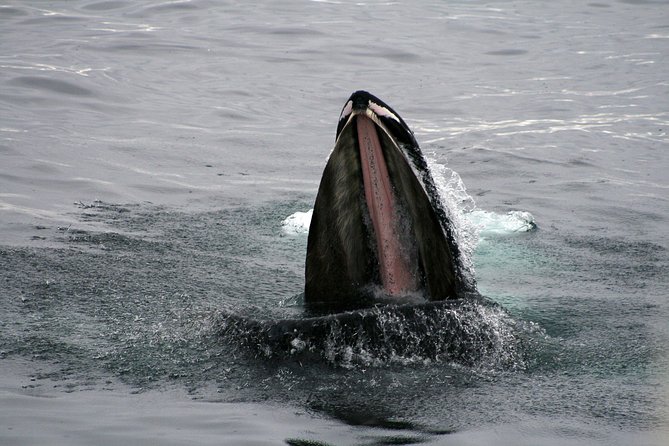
[0,0,669,446]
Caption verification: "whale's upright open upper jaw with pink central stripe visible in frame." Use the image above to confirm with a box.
[304,90,476,314]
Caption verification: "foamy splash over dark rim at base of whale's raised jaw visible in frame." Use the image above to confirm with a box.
[217,299,523,368]
